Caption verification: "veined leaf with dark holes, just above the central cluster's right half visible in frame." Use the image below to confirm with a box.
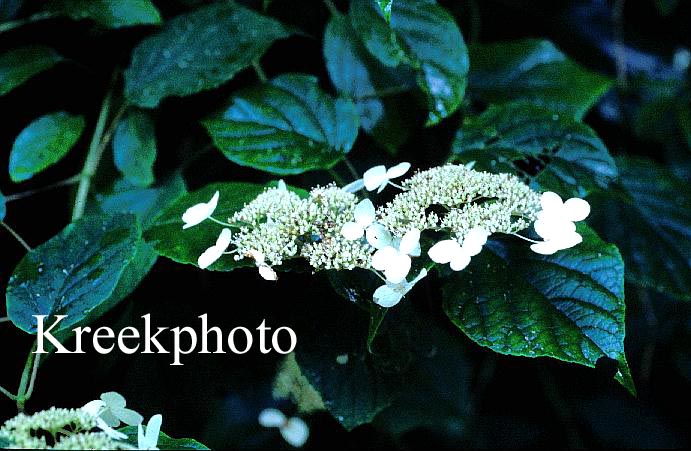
[452,102,617,196]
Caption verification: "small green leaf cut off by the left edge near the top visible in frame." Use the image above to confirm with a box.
[0,46,62,96]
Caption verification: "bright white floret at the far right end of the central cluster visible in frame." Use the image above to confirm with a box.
[530,191,590,255]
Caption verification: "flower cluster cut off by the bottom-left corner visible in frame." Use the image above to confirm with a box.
[0,392,162,450]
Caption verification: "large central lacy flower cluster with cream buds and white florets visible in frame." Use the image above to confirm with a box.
[182,163,590,307]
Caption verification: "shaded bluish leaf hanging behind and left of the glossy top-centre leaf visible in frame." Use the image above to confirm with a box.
[324,14,414,151]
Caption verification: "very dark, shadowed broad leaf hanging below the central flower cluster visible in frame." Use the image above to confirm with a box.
[295,299,429,430]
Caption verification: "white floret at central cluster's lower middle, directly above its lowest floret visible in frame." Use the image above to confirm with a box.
[372,229,420,284]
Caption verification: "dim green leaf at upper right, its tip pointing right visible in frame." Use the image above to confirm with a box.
[468,39,612,119]
